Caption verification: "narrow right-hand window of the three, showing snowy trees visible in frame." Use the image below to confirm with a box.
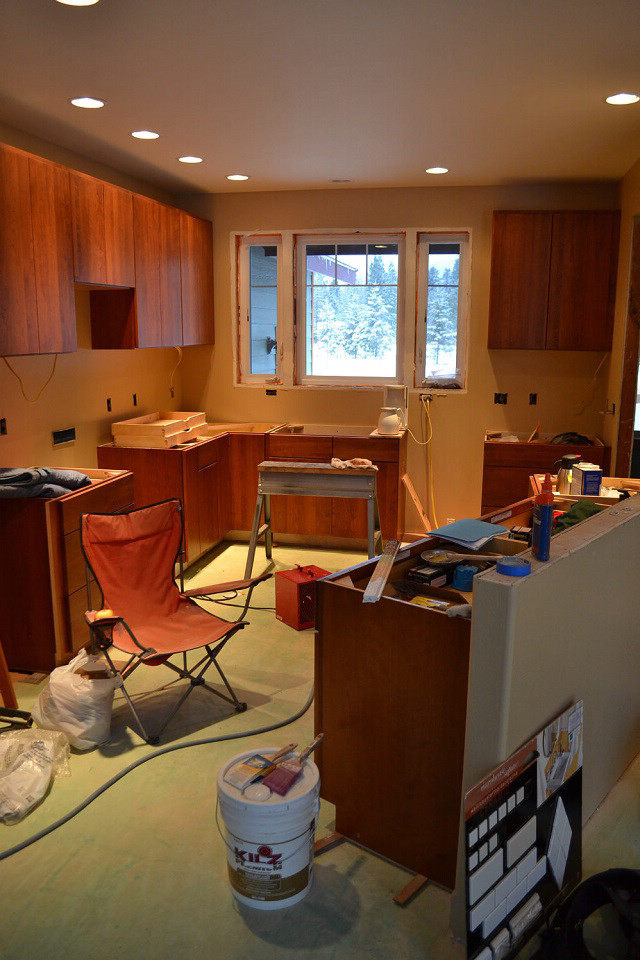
[416,234,469,389]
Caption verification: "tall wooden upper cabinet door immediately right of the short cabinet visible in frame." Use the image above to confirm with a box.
[133,194,182,347]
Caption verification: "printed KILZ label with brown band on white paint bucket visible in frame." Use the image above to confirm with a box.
[227,821,315,901]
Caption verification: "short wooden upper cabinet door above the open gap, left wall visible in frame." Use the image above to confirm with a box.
[70,171,135,287]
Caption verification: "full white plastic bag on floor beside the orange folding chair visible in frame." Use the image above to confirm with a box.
[31,650,118,750]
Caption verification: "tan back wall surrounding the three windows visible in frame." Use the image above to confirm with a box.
[181,183,617,530]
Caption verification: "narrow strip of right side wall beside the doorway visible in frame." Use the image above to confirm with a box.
[604,160,640,463]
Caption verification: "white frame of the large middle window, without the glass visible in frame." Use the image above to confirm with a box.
[294,230,406,387]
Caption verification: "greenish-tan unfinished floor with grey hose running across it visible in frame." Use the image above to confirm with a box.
[0,544,640,960]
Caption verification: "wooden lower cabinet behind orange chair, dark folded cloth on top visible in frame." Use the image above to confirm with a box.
[0,468,133,672]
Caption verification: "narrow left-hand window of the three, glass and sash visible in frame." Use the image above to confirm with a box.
[238,237,281,380]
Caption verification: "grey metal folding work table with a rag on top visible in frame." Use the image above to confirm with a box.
[245,460,381,577]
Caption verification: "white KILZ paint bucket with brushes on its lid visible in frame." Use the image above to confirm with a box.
[216,747,320,910]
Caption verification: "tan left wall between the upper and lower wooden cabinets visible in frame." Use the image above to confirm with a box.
[0,290,180,467]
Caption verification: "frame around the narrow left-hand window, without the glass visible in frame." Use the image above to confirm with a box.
[235,233,286,386]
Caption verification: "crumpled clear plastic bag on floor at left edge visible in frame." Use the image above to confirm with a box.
[0,729,69,823]
